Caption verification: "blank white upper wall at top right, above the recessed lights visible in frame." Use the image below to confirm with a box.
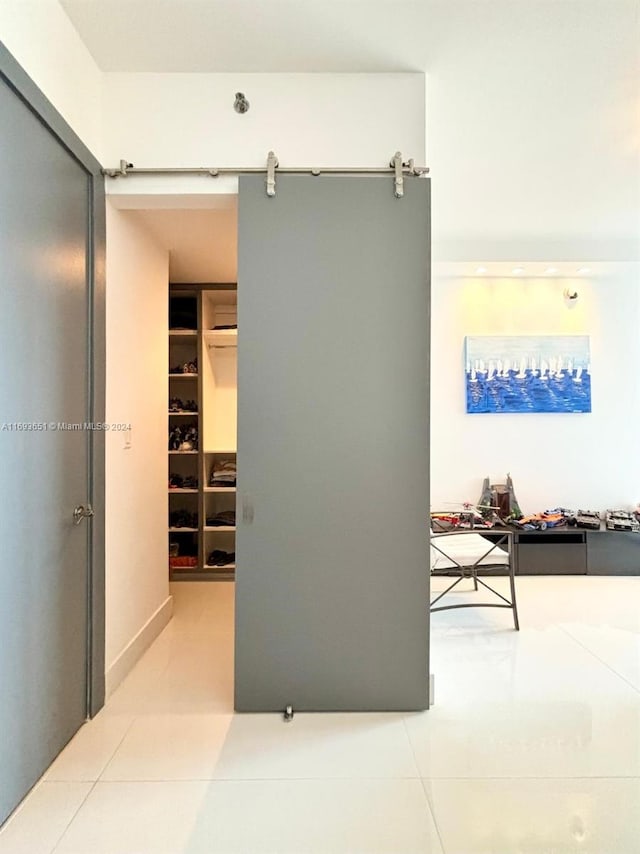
[426,0,640,261]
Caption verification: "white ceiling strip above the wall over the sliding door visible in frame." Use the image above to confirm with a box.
[60,0,488,72]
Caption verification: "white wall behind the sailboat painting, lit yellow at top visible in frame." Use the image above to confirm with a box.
[431,265,640,512]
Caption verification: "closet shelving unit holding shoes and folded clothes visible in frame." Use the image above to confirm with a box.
[168,284,238,581]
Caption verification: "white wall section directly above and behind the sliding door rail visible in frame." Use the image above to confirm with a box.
[104,73,425,199]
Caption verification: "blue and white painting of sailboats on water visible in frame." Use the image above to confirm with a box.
[465,335,591,413]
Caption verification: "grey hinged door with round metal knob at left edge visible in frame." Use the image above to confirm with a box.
[0,81,90,822]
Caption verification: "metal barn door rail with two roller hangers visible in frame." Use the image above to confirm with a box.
[102,151,429,199]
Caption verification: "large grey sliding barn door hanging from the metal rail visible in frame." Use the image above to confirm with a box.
[235,176,430,711]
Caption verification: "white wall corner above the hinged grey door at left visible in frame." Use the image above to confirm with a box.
[0,0,103,160]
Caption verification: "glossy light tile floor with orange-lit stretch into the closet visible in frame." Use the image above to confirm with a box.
[0,577,640,854]
